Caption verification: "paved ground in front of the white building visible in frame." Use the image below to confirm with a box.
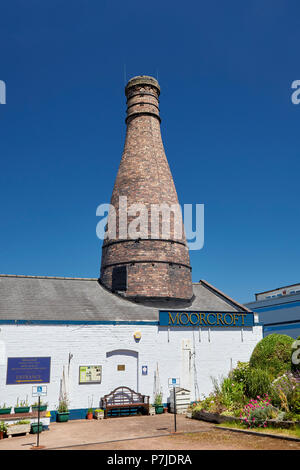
[0,414,300,450]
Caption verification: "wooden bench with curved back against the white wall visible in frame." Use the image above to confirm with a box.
[101,387,150,419]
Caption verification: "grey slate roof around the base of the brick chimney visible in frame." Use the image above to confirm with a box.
[0,274,250,321]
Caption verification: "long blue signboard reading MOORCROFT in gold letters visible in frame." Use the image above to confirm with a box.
[159,310,254,328]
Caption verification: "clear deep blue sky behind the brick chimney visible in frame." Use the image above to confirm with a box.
[0,0,300,302]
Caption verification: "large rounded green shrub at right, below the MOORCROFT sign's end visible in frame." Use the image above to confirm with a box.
[249,333,294,378]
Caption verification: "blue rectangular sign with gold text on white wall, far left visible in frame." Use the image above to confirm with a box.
[6,357,51,385]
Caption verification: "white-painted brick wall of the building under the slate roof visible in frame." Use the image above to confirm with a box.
[0,324,262,410]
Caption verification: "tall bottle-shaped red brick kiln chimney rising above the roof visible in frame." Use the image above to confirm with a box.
[100,75,193,305]
